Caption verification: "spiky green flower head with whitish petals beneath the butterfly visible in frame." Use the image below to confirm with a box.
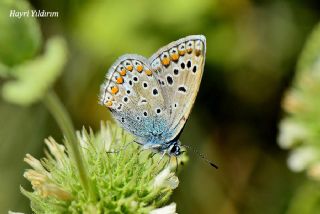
[21,123,179,213]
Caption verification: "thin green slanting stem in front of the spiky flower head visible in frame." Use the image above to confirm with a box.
[43,91,95,200]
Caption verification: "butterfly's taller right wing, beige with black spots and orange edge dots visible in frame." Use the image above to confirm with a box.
[149,35,206,140]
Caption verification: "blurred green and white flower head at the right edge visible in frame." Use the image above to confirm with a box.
[278,24,320,181]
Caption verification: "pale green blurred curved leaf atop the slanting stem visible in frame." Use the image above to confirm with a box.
[2,37,67,105]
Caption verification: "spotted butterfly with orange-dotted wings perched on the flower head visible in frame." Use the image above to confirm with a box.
[100,35,206,157]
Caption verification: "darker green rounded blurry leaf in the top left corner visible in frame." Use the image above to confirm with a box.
[0,0,42,66]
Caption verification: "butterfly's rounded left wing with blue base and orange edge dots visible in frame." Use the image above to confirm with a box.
[100,54,168,141]
